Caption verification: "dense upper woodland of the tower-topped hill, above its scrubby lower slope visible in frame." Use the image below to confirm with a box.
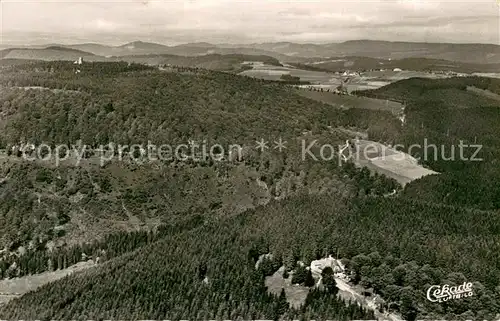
[0,62,376,146]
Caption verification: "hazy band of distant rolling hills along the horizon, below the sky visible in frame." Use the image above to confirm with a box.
[3,40,500,72]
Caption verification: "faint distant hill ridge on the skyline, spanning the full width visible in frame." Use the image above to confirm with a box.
[0,40,500,66]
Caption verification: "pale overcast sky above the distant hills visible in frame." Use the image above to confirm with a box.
[0,0,500,44]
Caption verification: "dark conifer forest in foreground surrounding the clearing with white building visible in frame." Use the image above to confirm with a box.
[0,194,500,319]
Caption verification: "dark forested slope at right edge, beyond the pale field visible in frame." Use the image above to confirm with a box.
[358,77,500,209]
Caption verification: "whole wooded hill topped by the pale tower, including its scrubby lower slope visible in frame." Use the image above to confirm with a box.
[0,62,397,270]
